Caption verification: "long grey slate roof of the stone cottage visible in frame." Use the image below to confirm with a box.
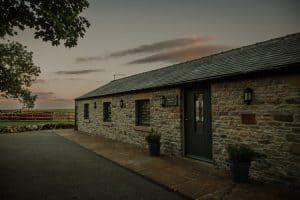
[76,33,300,100]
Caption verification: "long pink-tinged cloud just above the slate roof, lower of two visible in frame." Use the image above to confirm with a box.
[128,44,229,64]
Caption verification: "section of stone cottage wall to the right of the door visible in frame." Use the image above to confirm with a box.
[211,74,300,185]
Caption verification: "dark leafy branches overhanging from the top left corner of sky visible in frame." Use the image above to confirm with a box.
[0,0,90,47]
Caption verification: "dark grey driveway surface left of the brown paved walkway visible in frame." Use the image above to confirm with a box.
[0,131,183,200]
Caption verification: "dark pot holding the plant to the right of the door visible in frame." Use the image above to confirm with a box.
[230,162,251,182]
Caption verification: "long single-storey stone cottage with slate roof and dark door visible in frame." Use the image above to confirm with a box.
[75,33,300,185]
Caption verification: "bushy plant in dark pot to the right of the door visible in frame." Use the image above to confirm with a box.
[227,144,260,182]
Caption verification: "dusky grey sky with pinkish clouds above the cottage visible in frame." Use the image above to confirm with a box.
[0,0,300,109]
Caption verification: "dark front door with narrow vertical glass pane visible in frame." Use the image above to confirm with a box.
[184,88,212,160]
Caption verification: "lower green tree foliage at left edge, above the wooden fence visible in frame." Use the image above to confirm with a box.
[0,42,40,108]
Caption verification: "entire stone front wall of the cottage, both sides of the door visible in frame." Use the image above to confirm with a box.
[78,74,300,185]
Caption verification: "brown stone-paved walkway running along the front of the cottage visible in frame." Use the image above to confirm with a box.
[54,130,300,200]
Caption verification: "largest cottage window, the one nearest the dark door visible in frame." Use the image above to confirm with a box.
[135,100,150,126]
